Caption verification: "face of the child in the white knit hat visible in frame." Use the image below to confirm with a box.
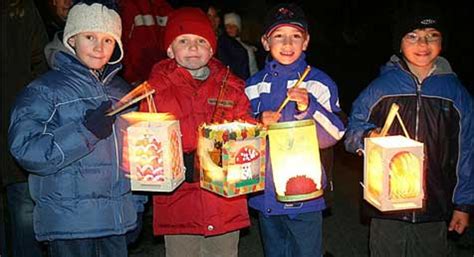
[68,32,115,70]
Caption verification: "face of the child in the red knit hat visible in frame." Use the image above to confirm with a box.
[167,34,213,70]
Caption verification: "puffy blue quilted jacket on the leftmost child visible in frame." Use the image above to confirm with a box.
[8,42,140,241]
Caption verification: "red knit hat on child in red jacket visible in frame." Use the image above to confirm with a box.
[164,7,217,53]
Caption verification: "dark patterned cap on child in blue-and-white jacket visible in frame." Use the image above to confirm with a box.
[263,3,308,36]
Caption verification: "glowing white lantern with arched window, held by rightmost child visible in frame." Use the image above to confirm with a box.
[364,136,424,211]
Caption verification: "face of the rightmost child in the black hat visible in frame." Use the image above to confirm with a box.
[401,28,442,69]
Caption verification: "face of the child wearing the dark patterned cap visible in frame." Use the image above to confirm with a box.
[262,26,309,65]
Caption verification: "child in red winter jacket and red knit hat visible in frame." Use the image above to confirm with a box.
[143,7,251,257]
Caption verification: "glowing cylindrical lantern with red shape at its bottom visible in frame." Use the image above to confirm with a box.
[268,120,323,202]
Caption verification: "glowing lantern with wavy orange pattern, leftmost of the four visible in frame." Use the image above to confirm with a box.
[118,112,184,192]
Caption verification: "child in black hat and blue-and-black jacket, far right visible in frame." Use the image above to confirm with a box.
[345,6,474,257]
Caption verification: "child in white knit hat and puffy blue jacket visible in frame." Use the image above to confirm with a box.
[9,3,144,257]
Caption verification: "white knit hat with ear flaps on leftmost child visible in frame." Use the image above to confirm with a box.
[63,3,123,64]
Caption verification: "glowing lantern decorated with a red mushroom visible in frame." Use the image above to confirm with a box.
[198,122,266,197]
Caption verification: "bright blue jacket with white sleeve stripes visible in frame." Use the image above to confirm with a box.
[245,54,344,215]
